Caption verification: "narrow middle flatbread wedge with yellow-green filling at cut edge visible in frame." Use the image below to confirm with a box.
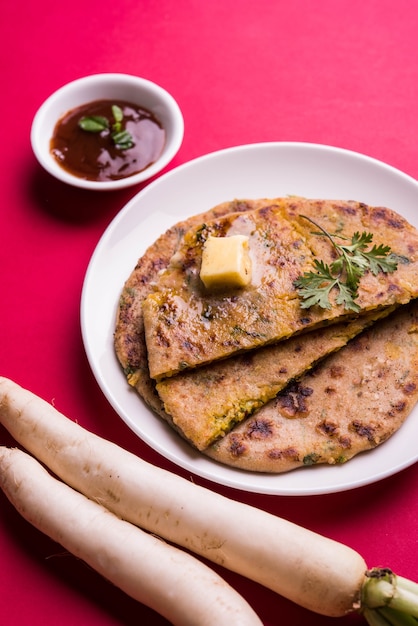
[156,307,391,450]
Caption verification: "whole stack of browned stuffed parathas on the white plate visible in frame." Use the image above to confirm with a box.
[115,198,418,472]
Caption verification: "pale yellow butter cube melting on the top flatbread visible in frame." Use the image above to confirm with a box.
[200,235,251,289]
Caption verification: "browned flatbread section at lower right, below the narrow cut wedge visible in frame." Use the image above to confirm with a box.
[205,300,418,473]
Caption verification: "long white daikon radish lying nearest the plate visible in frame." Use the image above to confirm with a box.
[0,378,415,616]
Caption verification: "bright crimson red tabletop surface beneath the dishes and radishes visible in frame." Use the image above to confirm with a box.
[0,0,418,626]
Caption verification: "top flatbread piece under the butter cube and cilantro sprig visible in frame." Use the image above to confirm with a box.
[143,198,418,380]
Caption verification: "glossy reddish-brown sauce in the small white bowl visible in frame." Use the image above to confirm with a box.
[50,100,165,181]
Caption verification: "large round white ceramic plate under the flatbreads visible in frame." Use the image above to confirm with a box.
[81,143,418,496]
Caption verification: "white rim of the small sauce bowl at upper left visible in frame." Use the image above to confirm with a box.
[30,72,184,191]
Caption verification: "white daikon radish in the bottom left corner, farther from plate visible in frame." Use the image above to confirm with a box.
[0,446,262,626]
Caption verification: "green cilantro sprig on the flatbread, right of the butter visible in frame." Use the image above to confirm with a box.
[294,215,398,312]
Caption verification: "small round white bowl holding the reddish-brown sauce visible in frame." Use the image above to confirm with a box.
[31,74,184,191]
